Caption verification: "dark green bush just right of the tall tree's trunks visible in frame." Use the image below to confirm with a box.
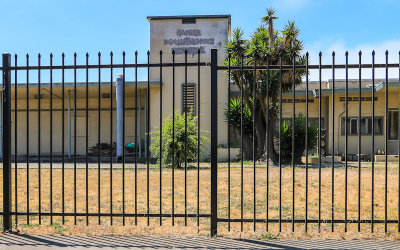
[275,113,318,163]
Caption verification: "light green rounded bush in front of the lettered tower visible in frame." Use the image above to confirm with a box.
[150,112,210,167]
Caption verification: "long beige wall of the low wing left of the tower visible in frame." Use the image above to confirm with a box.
[11,87,150,156]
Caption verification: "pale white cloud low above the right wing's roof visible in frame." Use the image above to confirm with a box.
[305,39,400,80]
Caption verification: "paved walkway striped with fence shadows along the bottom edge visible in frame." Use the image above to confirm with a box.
[0,234,400,250]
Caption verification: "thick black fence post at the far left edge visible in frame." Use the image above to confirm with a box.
[2,53,11,231]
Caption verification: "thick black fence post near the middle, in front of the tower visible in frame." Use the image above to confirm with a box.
[211,49,218,236]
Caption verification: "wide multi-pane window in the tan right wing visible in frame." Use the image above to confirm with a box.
[341,117,383,135]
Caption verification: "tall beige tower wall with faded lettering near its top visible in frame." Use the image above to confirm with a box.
[150,18,230,157]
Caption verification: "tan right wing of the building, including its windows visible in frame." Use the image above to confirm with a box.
[282,79,399,159]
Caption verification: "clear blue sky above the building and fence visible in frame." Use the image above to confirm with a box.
[0,0,400,78]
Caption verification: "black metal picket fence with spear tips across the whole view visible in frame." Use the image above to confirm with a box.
[0,50,400,235]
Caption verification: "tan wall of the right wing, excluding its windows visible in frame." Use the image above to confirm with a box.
[282,86,399,155]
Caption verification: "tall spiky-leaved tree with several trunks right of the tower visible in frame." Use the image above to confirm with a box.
[224,8,306,163]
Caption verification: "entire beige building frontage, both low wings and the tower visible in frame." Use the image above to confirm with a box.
[0,15,399,161]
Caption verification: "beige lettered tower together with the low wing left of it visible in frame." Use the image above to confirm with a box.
[1,15,231,158]
